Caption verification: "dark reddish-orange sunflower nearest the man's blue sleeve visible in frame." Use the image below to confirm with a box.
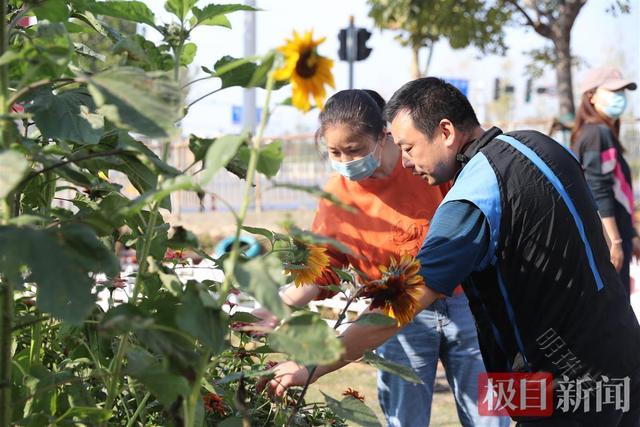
[362,255,424,326]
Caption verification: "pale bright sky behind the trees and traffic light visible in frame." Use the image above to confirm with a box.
[141,0,640,137]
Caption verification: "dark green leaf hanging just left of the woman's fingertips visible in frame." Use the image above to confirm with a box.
[176,286,227,354]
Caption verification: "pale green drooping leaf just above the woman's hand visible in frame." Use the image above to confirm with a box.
[231,254,289,319]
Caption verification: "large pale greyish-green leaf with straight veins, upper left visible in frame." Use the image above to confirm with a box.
[84,67,182,137]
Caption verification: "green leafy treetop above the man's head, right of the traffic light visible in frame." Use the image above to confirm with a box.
[368,0,510,78]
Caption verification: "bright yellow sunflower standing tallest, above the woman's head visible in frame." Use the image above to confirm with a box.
[274,31,335,111]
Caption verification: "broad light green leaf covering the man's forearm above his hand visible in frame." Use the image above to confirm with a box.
[268,311,344,365]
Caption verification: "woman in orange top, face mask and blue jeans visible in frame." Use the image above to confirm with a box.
[254,90,509,427]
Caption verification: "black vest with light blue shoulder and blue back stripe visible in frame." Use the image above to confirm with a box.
[450,128,640,379]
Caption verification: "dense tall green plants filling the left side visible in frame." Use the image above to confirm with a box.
[0,0,420,426]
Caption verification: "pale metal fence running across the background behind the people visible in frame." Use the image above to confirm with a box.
[111,120,640,214]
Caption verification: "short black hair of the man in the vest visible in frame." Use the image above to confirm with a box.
[384,77,480,138]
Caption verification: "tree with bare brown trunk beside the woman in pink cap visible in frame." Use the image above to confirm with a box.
[502,0,630,116]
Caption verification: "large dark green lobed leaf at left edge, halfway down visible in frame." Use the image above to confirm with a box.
[0,225,120,324]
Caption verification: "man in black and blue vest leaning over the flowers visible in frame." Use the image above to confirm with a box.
[268,78,640,426]
